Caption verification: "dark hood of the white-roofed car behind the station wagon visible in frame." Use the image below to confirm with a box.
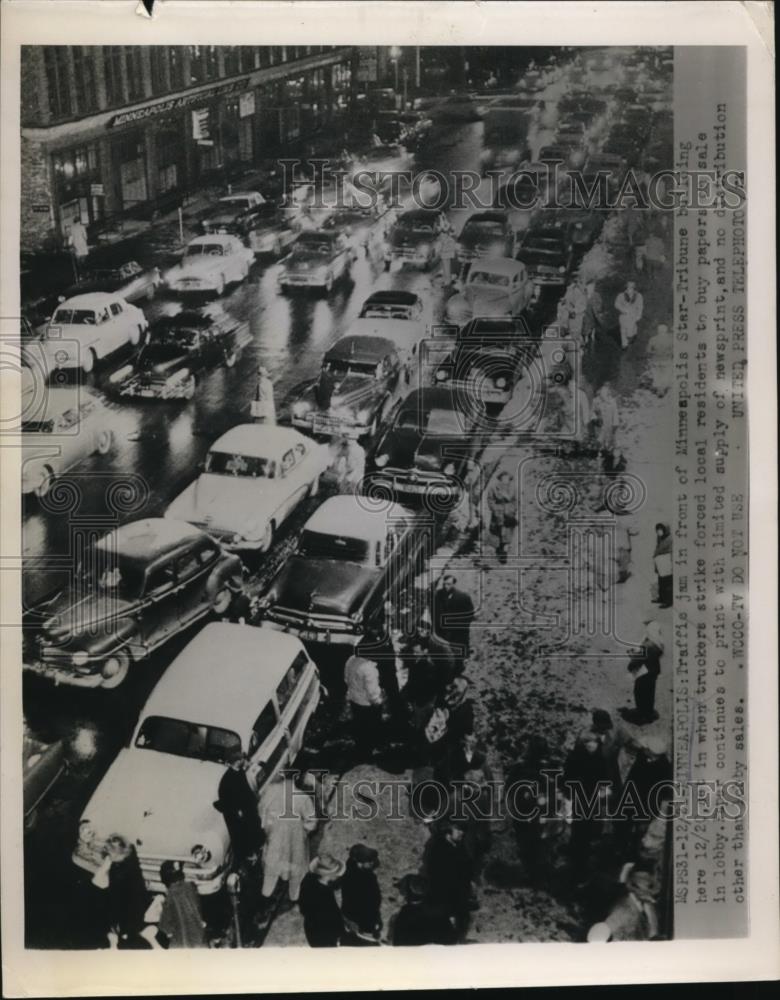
[274,556,381,616]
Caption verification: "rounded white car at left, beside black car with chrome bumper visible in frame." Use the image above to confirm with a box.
[42,292,149,374]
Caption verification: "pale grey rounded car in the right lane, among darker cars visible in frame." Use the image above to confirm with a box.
[445,257,534,326]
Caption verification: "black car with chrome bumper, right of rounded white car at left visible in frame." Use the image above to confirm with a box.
[112,309,247,400]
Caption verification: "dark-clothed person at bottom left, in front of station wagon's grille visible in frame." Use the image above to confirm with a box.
[92,833,149,948]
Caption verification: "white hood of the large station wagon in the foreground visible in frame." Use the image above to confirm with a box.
[83,747,227,858]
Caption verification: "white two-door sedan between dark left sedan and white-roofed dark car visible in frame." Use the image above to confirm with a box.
[165,424,330,552]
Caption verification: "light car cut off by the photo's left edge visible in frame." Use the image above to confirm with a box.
[22,378,114,497]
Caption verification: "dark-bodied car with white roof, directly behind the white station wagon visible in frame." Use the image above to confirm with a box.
[261,495,426,645]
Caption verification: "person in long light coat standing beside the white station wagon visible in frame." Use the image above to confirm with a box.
[258,775,317,905]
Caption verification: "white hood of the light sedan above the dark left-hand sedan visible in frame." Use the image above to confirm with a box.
[165,472,280,532]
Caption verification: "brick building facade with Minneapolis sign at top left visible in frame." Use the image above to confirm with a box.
[21,45,355,251]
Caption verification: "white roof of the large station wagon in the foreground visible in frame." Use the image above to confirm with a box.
[142,622,303,749]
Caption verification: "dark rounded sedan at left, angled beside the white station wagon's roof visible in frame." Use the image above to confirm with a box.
[24,518,242,688]
